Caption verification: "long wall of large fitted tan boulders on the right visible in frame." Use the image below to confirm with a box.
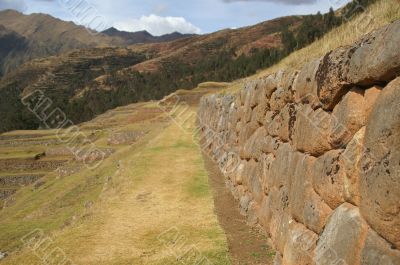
[199,21,400,265]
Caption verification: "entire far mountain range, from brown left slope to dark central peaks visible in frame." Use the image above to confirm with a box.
[0,9,195,76]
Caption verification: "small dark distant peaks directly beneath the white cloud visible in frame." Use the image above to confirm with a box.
[102,27,194,45]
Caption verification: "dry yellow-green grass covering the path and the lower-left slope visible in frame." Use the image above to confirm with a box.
[0,103,229,265]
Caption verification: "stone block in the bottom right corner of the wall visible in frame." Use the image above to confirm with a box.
[361,229,400,265]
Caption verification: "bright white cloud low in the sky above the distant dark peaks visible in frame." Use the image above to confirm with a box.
[114,14,201,36]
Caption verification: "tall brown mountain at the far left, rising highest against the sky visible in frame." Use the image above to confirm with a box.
[0,10,120,75]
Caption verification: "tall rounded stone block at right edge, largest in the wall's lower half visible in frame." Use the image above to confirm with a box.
[360,78,400,248]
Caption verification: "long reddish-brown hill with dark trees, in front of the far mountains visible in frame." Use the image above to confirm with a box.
[0,0,378,132]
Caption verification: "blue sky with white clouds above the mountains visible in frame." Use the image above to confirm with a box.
[0,0,348,35]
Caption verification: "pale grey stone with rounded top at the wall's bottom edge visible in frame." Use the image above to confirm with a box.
[316,203,368,265]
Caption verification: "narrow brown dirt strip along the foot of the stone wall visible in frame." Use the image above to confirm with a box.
[203,154,275,265]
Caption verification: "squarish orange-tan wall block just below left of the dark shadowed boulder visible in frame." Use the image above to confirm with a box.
[292,105,332,156]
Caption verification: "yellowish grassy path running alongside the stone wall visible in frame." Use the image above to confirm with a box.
[75,120,229,265]
